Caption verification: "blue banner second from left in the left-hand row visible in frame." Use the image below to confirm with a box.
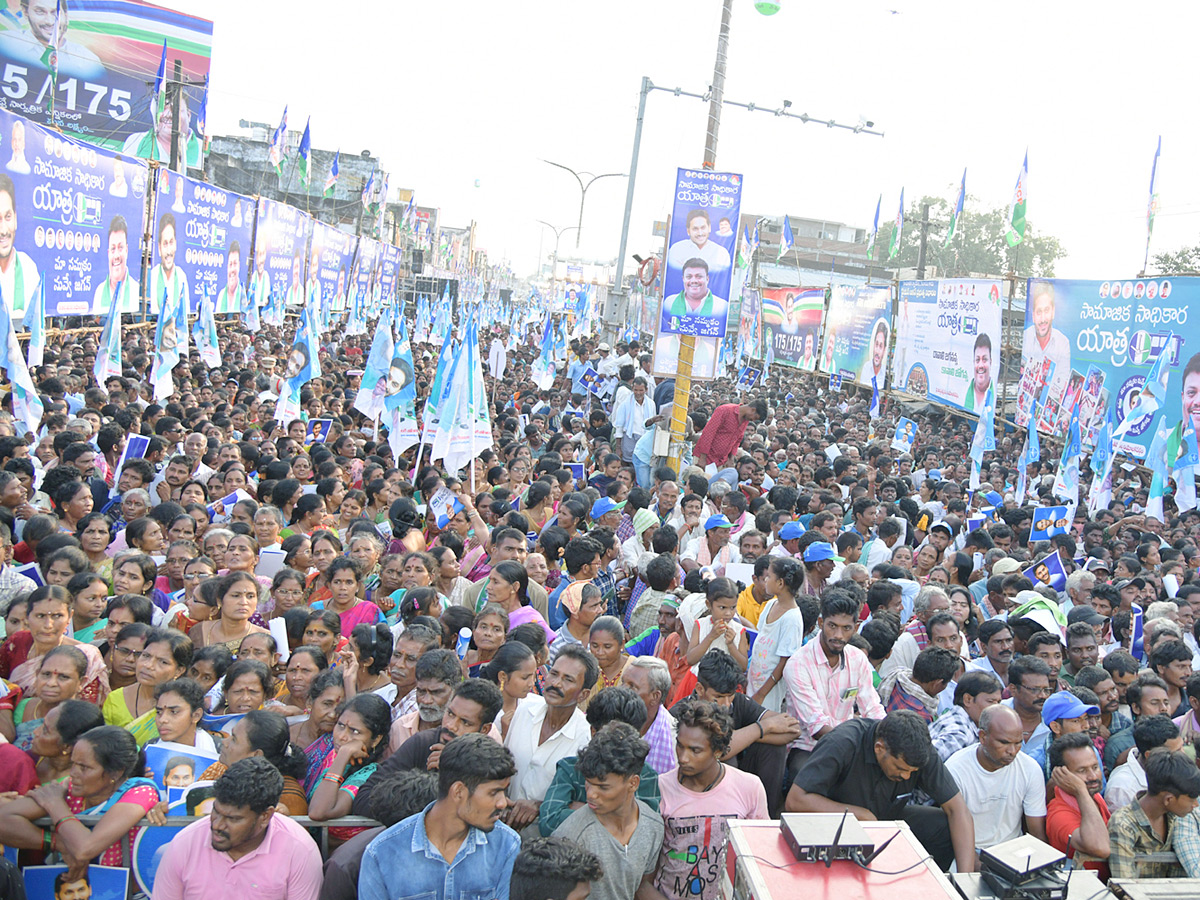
[146,169,254,316]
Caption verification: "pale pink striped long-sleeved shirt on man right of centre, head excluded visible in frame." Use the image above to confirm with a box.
[784,637,884,750]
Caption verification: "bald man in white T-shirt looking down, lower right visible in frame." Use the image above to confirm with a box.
[946,704,1046,850]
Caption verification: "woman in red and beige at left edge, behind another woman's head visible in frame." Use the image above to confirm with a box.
[0,584,108,703]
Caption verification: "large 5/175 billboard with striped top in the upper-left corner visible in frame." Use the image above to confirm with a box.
[0,0,212,153]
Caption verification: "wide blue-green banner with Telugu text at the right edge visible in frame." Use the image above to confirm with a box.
[1021,277,1200,462]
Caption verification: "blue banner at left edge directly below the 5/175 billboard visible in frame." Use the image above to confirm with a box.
[0,104,148,323]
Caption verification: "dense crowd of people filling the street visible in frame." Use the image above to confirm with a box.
[0,312,1200,900]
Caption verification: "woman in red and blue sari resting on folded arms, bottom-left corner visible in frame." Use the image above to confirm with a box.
[0,725,158,866]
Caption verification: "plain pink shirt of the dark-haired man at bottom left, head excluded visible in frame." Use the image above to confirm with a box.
[151,815,322,900]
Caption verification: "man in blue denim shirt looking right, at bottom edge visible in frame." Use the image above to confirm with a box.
[359,734,521,900]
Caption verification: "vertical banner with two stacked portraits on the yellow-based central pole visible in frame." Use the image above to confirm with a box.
[654,169,742,378]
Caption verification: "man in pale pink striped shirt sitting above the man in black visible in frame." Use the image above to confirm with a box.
[784,588,884,772]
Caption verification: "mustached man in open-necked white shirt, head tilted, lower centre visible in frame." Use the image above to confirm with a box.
[504,644,600,832]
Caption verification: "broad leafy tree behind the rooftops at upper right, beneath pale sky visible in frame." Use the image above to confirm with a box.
[875,196,1066,278]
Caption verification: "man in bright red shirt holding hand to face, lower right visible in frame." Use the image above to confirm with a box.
[1046,731,1109,881]
